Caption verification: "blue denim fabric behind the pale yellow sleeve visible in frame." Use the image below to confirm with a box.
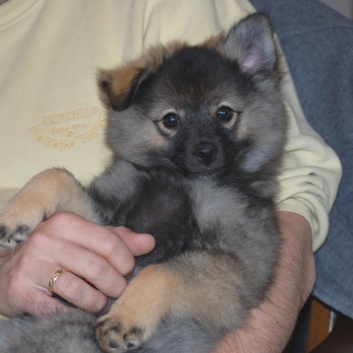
[251,0,353,318]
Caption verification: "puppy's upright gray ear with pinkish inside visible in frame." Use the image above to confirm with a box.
[224,13,278,76]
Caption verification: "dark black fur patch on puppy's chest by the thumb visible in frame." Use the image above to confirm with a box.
[114,177,199,262]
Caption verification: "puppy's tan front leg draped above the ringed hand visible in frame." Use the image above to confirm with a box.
[0,169,99,255]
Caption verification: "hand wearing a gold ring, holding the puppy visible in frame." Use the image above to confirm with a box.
[0,212,155,316]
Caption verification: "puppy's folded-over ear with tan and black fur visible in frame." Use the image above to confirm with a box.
[98,62,149,111]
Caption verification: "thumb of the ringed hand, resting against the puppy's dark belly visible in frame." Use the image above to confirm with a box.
[112,227,156,256]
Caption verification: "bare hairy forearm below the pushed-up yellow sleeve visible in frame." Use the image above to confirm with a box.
[216,212,316,353]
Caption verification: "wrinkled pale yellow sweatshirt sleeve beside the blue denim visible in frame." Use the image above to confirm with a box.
[276,59,342,251]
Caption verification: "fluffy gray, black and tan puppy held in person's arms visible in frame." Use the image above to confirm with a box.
[0,13,287,353]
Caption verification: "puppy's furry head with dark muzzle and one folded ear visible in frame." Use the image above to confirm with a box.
[99,14,286,177]
